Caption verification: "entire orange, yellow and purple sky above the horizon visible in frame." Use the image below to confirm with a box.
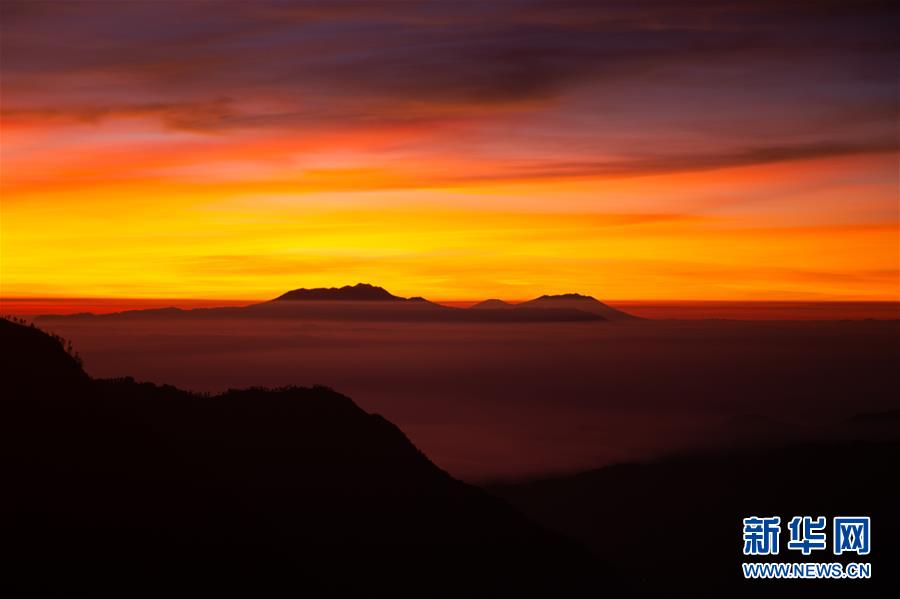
[0,0,900,300]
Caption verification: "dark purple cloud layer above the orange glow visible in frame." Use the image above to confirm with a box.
[3,0,900,170]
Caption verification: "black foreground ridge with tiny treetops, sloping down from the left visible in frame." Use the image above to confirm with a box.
[0,320,602,597]
